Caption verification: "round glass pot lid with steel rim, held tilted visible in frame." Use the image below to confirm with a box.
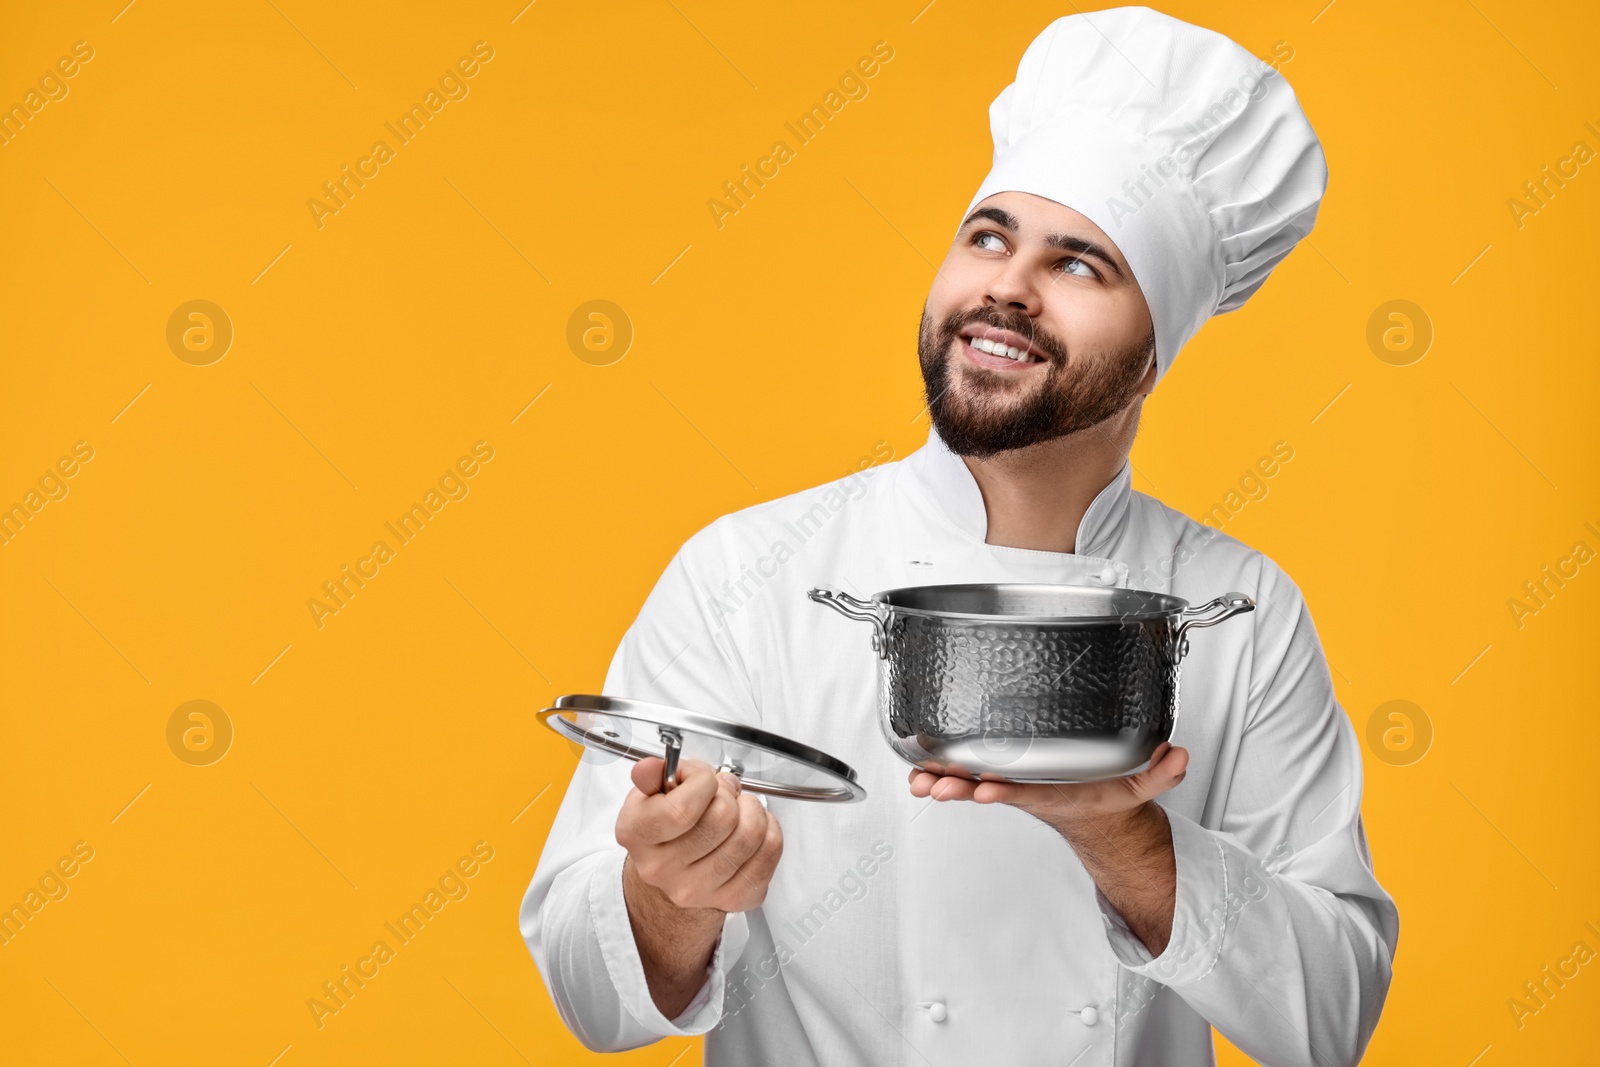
[539,693,867,803]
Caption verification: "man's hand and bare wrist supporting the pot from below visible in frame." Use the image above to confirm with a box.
[910,741,1189,955]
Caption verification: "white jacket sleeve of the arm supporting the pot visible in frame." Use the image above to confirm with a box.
[1096,563,1400,1067]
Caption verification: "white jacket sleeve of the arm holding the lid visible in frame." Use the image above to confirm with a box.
[518,520,757,1053]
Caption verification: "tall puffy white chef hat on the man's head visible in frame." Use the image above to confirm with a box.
[962,8,1328,383]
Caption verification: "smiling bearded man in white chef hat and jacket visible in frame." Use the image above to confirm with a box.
[520,8,1398,1067]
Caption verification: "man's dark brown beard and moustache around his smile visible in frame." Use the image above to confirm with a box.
[917,307,1155,459]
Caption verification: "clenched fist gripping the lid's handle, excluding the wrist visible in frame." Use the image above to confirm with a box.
[616,758,784,913]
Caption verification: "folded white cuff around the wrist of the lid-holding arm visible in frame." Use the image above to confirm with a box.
[589,848,750,1037]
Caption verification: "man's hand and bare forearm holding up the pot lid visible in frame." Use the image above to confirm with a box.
[616,758,784,1019]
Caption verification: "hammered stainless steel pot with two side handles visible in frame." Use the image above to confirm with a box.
[808,584,1256,782]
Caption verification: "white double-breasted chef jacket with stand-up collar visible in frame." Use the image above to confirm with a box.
[520,432,1398,1067]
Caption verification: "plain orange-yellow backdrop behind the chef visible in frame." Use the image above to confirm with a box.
[0,0,1600,1067]
